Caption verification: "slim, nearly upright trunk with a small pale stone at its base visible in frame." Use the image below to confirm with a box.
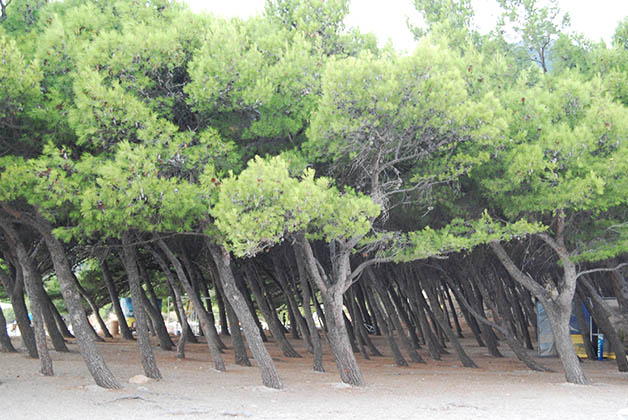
[121,232,162,380]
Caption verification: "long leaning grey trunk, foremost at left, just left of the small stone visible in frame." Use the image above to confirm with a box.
[28,216,120,389]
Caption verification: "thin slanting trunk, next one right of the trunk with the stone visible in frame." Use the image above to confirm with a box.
[157,239,225,372]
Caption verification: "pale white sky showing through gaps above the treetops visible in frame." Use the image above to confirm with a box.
[184,0,628,51]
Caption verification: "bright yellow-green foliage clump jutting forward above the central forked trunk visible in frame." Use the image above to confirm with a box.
[212,157,379,256]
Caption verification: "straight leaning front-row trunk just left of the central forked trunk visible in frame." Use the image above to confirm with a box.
[207,241,283,389]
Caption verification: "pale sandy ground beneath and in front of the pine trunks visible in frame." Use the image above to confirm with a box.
[0,337,628,420]
